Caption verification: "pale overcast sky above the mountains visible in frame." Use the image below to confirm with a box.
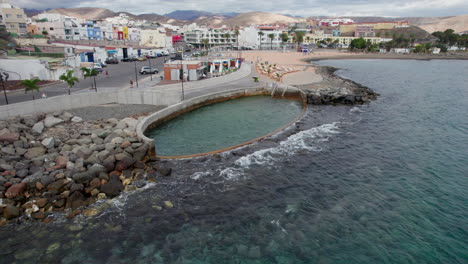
[11,0,468,16]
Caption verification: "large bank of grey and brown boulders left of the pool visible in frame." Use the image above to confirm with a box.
[0,112,171,226]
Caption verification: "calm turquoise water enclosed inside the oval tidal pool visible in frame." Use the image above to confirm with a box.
[146,96,302,156]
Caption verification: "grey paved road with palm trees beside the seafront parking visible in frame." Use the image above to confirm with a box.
[0,57,168,105]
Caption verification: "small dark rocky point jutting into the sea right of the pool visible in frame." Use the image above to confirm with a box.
[296,66,379,105]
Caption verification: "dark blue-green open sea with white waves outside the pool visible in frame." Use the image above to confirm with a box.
[0,60,468,264]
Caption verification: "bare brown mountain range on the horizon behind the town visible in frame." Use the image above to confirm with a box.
[30,7,468,33]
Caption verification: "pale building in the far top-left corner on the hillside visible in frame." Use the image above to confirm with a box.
[0,0,28,35]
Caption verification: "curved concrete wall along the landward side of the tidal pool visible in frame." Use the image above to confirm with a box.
[136,87,307,156]
